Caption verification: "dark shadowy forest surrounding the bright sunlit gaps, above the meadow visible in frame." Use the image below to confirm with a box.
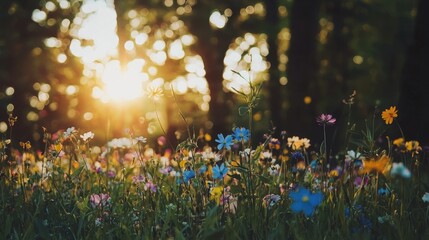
[0,0,429,149]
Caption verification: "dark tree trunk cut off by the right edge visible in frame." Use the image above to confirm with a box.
[398,0,429,144]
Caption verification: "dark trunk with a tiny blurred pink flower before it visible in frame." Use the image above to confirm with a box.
[286,0,320,137]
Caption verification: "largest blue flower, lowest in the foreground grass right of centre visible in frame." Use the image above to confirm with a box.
[289,187,323,217]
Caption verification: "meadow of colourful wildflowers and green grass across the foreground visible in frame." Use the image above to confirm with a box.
[0,86,429,239]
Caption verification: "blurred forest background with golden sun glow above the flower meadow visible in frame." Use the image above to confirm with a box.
[0,0,429,148]
